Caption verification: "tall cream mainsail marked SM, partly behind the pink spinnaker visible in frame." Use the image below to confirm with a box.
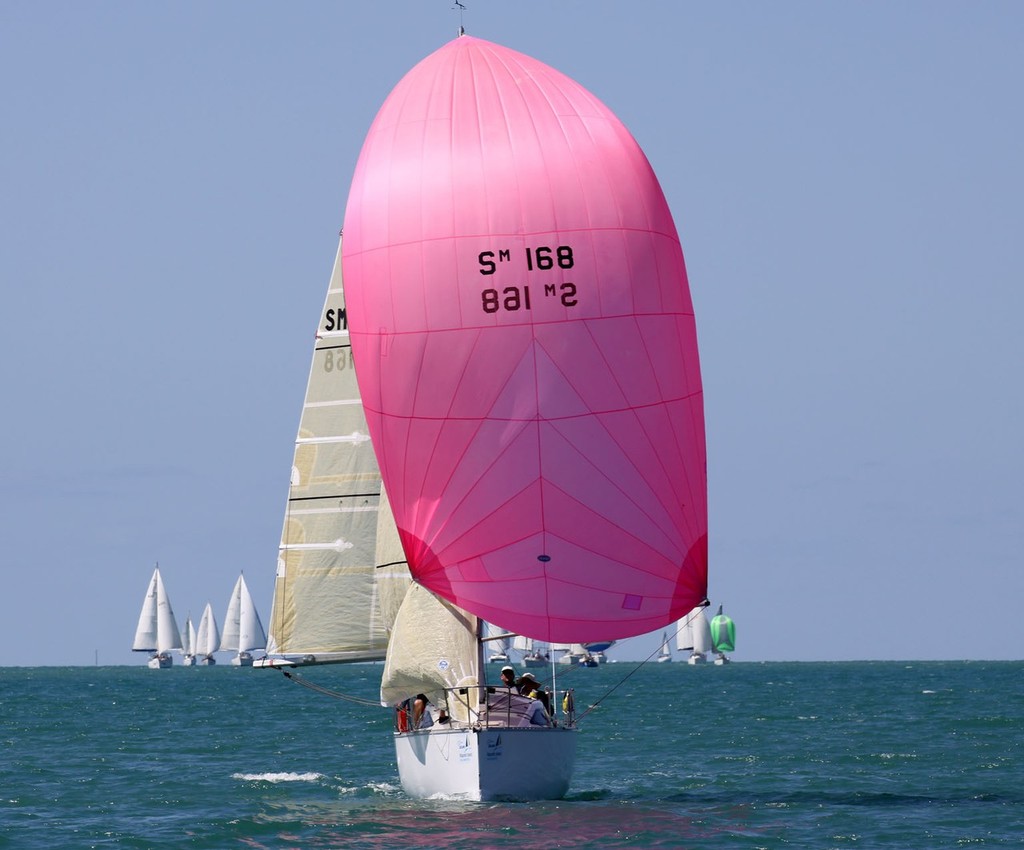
[267,242,409,663]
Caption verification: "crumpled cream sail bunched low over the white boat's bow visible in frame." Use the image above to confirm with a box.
[381,584,478,721]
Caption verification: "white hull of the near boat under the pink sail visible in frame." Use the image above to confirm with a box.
[394,726,578,801]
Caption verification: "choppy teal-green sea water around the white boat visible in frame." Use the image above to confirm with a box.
[0,662,1024,850]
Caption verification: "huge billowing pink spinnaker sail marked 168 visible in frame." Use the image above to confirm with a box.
[342,36,708,642]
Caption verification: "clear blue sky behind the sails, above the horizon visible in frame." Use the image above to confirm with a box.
[0,0,1024,665]
